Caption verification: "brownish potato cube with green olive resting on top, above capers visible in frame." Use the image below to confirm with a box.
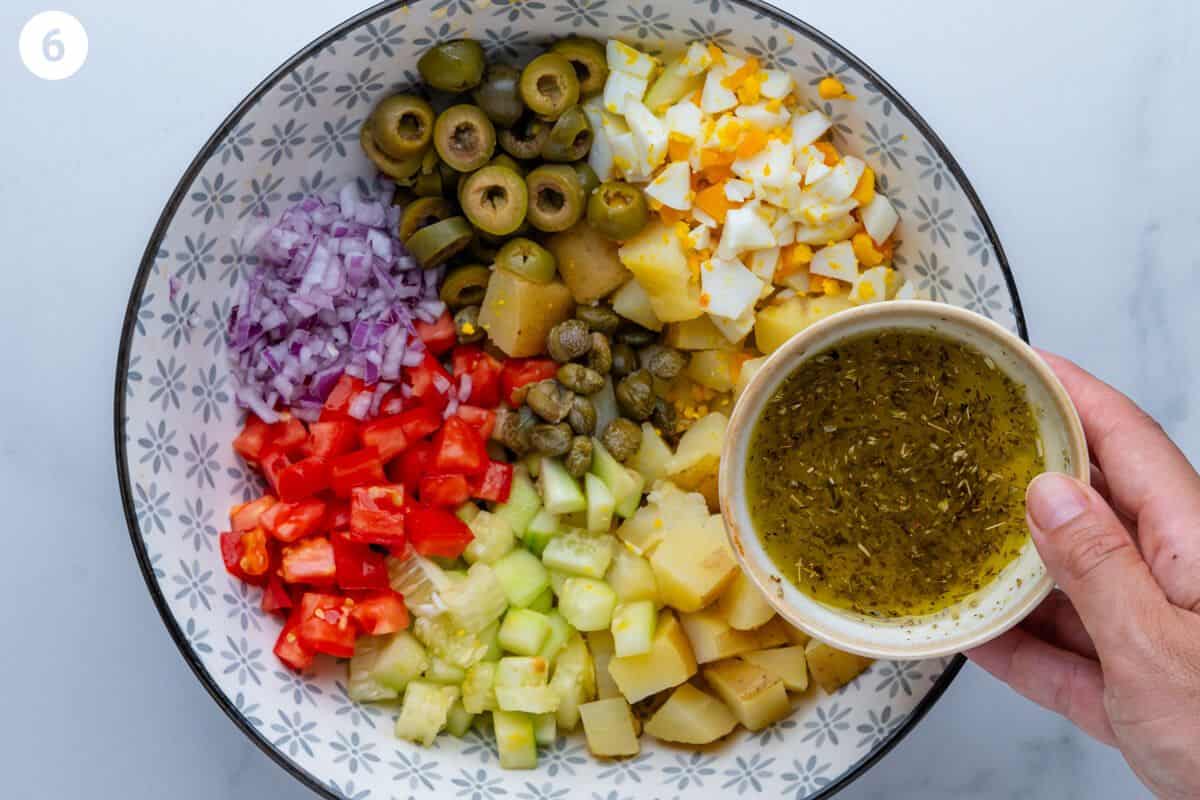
[479,270,575,357]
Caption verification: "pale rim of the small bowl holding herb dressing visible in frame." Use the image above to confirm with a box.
[718,300,1090,661]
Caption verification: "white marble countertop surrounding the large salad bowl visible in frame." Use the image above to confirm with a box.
[0,0,1185,800]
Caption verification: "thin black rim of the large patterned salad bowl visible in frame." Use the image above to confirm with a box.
[113,0,1028,800]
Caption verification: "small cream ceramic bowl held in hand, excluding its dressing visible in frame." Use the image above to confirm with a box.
[720,301,1090,660]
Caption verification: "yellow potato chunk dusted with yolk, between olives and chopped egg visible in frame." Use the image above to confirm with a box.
[619,222,704,323]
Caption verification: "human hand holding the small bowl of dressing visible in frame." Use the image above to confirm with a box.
[967,353,1200,800]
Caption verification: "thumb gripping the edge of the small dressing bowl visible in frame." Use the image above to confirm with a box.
[1025,473,1166,660]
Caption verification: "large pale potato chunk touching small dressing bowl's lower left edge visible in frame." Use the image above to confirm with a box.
[650,515,738,612]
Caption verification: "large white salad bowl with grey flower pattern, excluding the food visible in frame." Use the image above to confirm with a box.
[115,0,1025,800]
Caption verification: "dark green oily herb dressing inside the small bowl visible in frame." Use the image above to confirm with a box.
[746,330,1044,616]
